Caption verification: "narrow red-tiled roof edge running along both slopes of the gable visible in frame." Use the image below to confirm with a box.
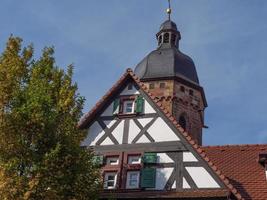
[78,69,245,200]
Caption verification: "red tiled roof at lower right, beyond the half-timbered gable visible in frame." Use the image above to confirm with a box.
[202,144,267,200]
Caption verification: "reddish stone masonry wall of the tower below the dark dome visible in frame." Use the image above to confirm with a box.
[144,80,204,144]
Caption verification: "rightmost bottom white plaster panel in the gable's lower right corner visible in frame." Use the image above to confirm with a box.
[186,167,220,188]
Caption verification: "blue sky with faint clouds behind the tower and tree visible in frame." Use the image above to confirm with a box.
[0,0,267,145]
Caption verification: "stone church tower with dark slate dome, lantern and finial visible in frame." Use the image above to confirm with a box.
[134,8,207,145]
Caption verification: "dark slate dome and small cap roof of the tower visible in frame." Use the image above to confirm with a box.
[134,20,199,85]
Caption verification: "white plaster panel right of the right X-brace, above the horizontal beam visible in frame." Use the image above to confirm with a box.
[147,117,180,142]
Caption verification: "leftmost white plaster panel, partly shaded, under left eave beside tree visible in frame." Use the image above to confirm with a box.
[81,122,105,146]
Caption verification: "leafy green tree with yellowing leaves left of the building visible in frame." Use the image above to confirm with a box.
[0,36,100,200]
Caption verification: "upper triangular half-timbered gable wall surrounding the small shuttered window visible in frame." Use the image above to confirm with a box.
[82,82,180,146]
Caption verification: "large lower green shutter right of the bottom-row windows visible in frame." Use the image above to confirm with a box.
[141,168,156,188]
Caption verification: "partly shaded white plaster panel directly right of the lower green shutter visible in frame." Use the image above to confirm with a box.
[155,167,173,190]
